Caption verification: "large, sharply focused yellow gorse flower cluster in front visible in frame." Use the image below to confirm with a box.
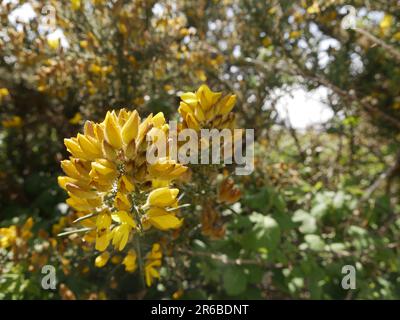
[58,109,187,270]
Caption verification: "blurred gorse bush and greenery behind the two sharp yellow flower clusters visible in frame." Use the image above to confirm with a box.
[0,0,400,299]
